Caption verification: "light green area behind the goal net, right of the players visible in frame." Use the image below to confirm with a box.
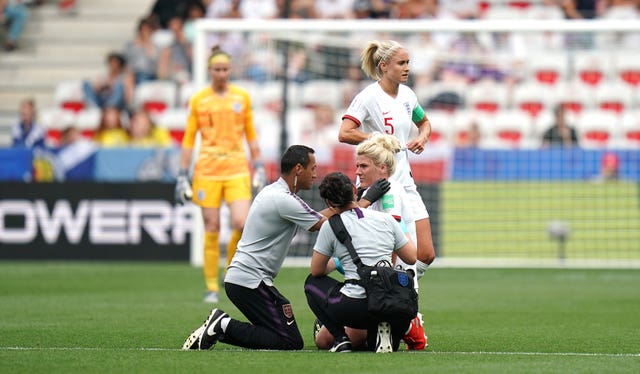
[440,181,640,259]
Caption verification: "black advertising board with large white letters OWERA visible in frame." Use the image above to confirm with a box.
[0,182,193,261]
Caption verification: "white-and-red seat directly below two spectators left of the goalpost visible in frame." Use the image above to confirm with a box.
[133,80,178,113]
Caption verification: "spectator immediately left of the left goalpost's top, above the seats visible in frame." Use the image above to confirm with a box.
[158,16,192,85]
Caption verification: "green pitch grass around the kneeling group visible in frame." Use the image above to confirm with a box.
[0,262,640,374]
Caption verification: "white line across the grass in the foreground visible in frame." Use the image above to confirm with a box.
[0,347,640,357]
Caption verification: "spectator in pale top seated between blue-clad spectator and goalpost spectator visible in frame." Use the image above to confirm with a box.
[124,18,160,85]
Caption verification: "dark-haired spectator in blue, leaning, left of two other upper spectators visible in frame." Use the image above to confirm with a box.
[82,52,133,110]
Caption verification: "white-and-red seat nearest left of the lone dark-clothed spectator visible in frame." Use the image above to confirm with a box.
[478,110,537,149]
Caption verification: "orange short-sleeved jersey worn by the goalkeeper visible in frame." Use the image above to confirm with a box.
[182,84,257,180]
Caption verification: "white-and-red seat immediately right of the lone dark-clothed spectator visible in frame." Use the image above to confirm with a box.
[575,109,619,149]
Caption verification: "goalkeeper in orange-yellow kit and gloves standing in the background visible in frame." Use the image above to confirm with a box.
[175,46,266,303]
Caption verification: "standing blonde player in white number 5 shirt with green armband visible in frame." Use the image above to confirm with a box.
[338,40,435,278]
